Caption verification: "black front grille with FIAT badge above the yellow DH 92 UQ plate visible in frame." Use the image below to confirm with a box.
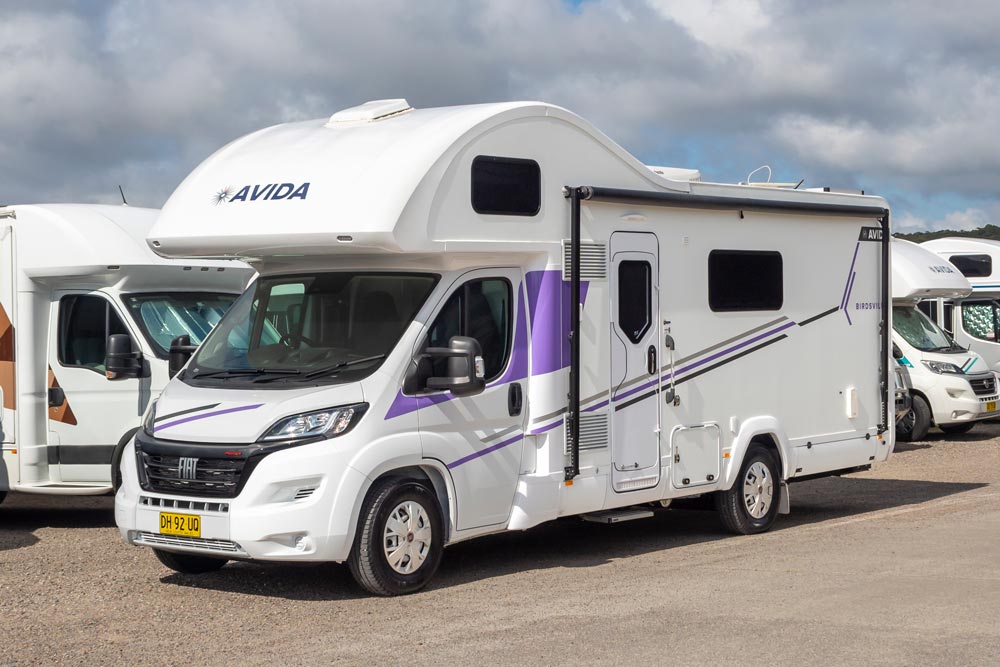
[142,452,246,498]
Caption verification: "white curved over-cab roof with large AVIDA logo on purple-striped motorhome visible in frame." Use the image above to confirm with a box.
[149,100,881,263]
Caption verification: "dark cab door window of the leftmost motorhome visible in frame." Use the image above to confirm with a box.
[57,295,128,374]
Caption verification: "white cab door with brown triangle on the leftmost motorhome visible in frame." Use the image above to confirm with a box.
[48,292,149,484]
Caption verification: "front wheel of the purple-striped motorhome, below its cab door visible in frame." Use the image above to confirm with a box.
[347,479,444,596]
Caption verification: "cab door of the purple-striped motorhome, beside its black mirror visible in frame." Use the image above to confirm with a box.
[417,269,527,529]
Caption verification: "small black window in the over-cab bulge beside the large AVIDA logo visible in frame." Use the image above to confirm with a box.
[472,155,542,215]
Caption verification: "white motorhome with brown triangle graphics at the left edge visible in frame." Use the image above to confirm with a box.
[0,204,253,500]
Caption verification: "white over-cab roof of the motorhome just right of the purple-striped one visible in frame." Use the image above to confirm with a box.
[892,239,972,301]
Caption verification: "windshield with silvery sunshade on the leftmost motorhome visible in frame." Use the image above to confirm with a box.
[123,292,236,359]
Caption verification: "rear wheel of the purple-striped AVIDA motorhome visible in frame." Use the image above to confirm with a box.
[715,444,781,535]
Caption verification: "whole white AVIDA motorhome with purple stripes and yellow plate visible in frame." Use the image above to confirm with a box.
[115,100,893,595]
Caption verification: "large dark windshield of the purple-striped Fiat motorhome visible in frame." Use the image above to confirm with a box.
[184,272,437,384]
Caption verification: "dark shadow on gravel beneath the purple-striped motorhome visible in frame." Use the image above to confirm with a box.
[161,477,985,600]
